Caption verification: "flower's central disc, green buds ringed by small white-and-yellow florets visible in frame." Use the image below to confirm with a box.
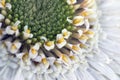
[0,0,99,80]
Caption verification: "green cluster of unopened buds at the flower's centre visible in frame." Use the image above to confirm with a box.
[7,0,74,41]
